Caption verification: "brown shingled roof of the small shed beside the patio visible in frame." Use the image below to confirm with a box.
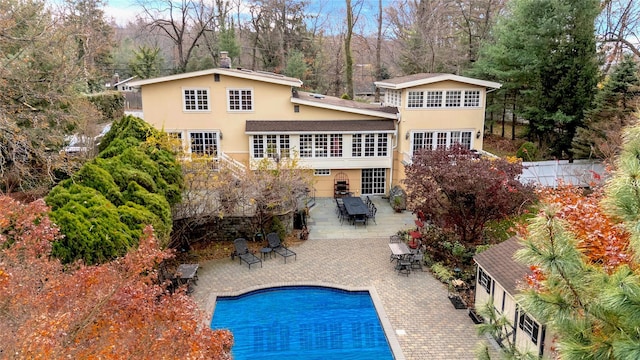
[473,236,531,296]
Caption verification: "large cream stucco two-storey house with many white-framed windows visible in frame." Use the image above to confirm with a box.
[129,58,500,197]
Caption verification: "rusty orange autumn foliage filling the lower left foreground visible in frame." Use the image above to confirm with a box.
[0,196,232,359]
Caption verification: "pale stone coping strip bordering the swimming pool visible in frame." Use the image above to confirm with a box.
[203,281,406,360]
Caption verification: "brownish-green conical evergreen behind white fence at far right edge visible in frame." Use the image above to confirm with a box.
[572,56,640,159]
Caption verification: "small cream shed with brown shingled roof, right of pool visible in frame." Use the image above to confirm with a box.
[473,237,552,358]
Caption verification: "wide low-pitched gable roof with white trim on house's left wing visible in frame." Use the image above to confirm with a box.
[129,68,302,87]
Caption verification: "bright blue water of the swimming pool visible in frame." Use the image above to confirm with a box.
[211,286,393,360]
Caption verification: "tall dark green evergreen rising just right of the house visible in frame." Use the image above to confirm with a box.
[476,0,599,157]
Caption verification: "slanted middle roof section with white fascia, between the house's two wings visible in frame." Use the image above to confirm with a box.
[291,91,398,119]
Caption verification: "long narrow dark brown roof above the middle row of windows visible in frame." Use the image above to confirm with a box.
[246,120,395,134]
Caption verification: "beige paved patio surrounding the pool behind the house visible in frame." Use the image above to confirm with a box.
[193,198,493,360]
